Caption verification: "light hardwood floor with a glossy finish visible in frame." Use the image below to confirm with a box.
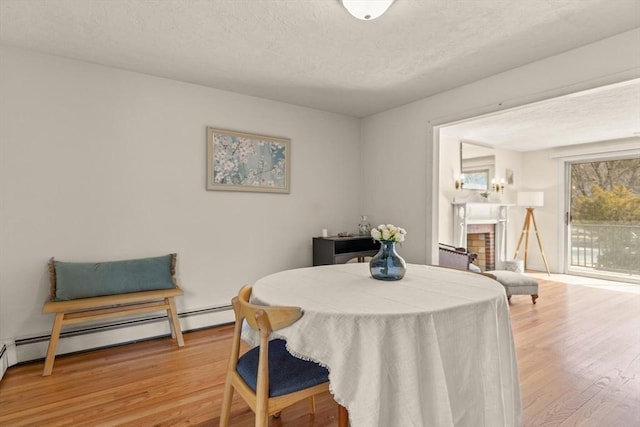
[0,280,640,427]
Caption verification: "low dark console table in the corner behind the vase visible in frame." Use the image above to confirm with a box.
[313,236,380,266]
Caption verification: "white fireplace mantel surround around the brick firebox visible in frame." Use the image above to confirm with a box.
[452,202,514,269]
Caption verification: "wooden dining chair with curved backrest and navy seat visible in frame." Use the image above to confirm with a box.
[220,286,329,427]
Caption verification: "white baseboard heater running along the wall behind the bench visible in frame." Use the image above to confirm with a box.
[5,305,235,369]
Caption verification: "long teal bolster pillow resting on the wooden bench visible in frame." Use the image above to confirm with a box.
[54,255,175,301]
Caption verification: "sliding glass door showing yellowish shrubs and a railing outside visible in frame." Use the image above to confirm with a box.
[566,157,640,282]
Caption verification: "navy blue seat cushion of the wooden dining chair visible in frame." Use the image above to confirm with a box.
[236,339,329,397]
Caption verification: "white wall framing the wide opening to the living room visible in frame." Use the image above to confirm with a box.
[361,29,640,263]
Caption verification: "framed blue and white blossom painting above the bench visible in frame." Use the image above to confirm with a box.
[207,127,291,193]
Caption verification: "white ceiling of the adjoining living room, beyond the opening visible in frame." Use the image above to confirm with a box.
[441,79,640,151]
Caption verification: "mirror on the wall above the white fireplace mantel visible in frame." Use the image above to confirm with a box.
[459,141,496,192]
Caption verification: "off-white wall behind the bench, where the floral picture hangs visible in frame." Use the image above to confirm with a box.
[0,48,361,362]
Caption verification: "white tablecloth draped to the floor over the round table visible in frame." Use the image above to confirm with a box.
[252,263,522,427]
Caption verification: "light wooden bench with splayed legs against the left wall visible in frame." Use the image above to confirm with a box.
[42,254,184,376]
